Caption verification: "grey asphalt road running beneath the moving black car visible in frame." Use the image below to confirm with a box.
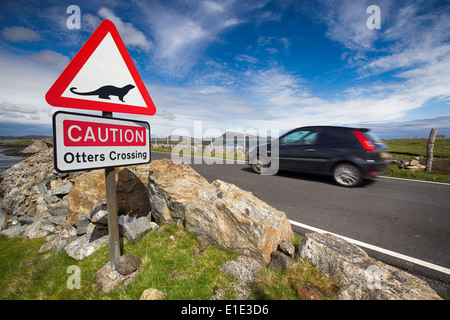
[152,152,450,284]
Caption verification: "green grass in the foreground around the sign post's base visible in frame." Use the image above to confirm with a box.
[0,225,338,300]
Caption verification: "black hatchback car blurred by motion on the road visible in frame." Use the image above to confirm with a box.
[249,126,388,187]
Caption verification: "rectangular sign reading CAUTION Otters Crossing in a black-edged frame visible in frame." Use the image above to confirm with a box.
[53,111,150,172]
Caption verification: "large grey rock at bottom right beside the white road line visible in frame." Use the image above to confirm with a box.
[298,233,440,300]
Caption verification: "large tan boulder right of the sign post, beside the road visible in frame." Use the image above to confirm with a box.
[148,159,293,264]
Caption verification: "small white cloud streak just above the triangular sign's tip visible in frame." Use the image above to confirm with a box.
[97,8,153,52]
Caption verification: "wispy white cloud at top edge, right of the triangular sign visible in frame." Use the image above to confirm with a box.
[140,0,273,77]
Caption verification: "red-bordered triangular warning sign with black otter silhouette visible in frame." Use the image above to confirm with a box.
[45,20,156,115]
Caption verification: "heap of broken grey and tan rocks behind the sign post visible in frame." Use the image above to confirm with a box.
[0,148,155,260]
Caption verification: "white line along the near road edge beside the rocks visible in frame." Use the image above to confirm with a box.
[289,220,450,275]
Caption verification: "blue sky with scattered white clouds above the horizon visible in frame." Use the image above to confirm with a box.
[0,0,450,139]
